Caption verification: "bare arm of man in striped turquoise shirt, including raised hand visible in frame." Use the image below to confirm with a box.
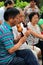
[8,30,30,54]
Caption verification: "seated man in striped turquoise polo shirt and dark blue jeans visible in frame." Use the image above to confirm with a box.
[0,8,39,65]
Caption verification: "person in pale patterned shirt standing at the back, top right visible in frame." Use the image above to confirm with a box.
[24,0,39,23]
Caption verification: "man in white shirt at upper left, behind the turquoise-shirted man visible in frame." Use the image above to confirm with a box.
[0,0,14,24]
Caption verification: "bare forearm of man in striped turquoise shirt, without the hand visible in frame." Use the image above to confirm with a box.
[8,36,27,54]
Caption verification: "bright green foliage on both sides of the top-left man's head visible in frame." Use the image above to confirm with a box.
[0,0,29,9]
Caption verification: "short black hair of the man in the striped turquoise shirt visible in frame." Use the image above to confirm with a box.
[4,7,20,21]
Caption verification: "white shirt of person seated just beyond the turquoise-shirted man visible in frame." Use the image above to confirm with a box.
[12,23,27,50]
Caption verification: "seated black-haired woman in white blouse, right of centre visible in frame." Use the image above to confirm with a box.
[27,12,43,62]
